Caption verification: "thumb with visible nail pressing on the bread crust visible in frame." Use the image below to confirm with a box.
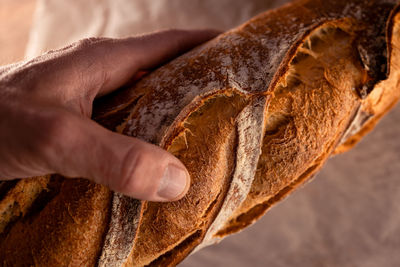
[44,112,190,201]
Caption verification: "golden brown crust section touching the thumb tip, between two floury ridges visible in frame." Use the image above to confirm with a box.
[127,92,248,266]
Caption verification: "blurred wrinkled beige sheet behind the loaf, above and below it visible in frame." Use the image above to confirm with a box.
[27,0,400,267]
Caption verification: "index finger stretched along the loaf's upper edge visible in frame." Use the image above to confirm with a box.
[17,30,219,100]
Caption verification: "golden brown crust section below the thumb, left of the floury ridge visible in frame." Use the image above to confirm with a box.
[0,179,111,266]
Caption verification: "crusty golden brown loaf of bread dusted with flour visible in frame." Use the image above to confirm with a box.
[0,0,400,266]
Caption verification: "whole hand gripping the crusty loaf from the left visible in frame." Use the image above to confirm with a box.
[0,30,218,201]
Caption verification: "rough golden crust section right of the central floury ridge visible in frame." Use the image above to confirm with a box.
[219,20,364,235]
